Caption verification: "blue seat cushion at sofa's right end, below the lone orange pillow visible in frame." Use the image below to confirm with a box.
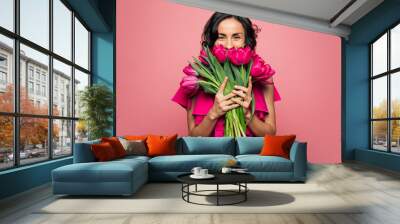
[236,155,293,172]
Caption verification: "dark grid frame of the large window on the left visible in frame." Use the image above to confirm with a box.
[0,0,93,172]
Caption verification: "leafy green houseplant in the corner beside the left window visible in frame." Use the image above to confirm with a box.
[79,84,113,140]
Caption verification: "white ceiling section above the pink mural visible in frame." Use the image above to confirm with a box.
[171,0,383,38]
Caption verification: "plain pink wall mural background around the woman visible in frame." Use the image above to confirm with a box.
[116,0,341,163]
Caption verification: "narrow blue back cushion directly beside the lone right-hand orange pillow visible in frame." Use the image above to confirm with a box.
[236,137,264,155]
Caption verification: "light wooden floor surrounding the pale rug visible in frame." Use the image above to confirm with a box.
[0,163,400,224]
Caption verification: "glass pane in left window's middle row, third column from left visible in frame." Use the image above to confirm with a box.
[53,59,72,117]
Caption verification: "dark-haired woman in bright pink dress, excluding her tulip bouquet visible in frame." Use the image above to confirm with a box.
[172,12,280,137]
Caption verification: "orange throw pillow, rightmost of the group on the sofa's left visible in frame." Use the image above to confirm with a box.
[146,134,178,156]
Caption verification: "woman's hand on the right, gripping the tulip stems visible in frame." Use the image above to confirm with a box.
[232,76,253,125]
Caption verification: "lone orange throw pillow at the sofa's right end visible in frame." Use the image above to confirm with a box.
[260,135,296,159]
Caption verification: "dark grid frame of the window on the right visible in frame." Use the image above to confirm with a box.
[368,21,400,155]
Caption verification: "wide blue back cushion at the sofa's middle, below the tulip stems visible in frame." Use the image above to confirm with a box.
[180,137,235,155]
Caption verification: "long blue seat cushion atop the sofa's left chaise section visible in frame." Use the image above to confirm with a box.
[52,159,148,182]
